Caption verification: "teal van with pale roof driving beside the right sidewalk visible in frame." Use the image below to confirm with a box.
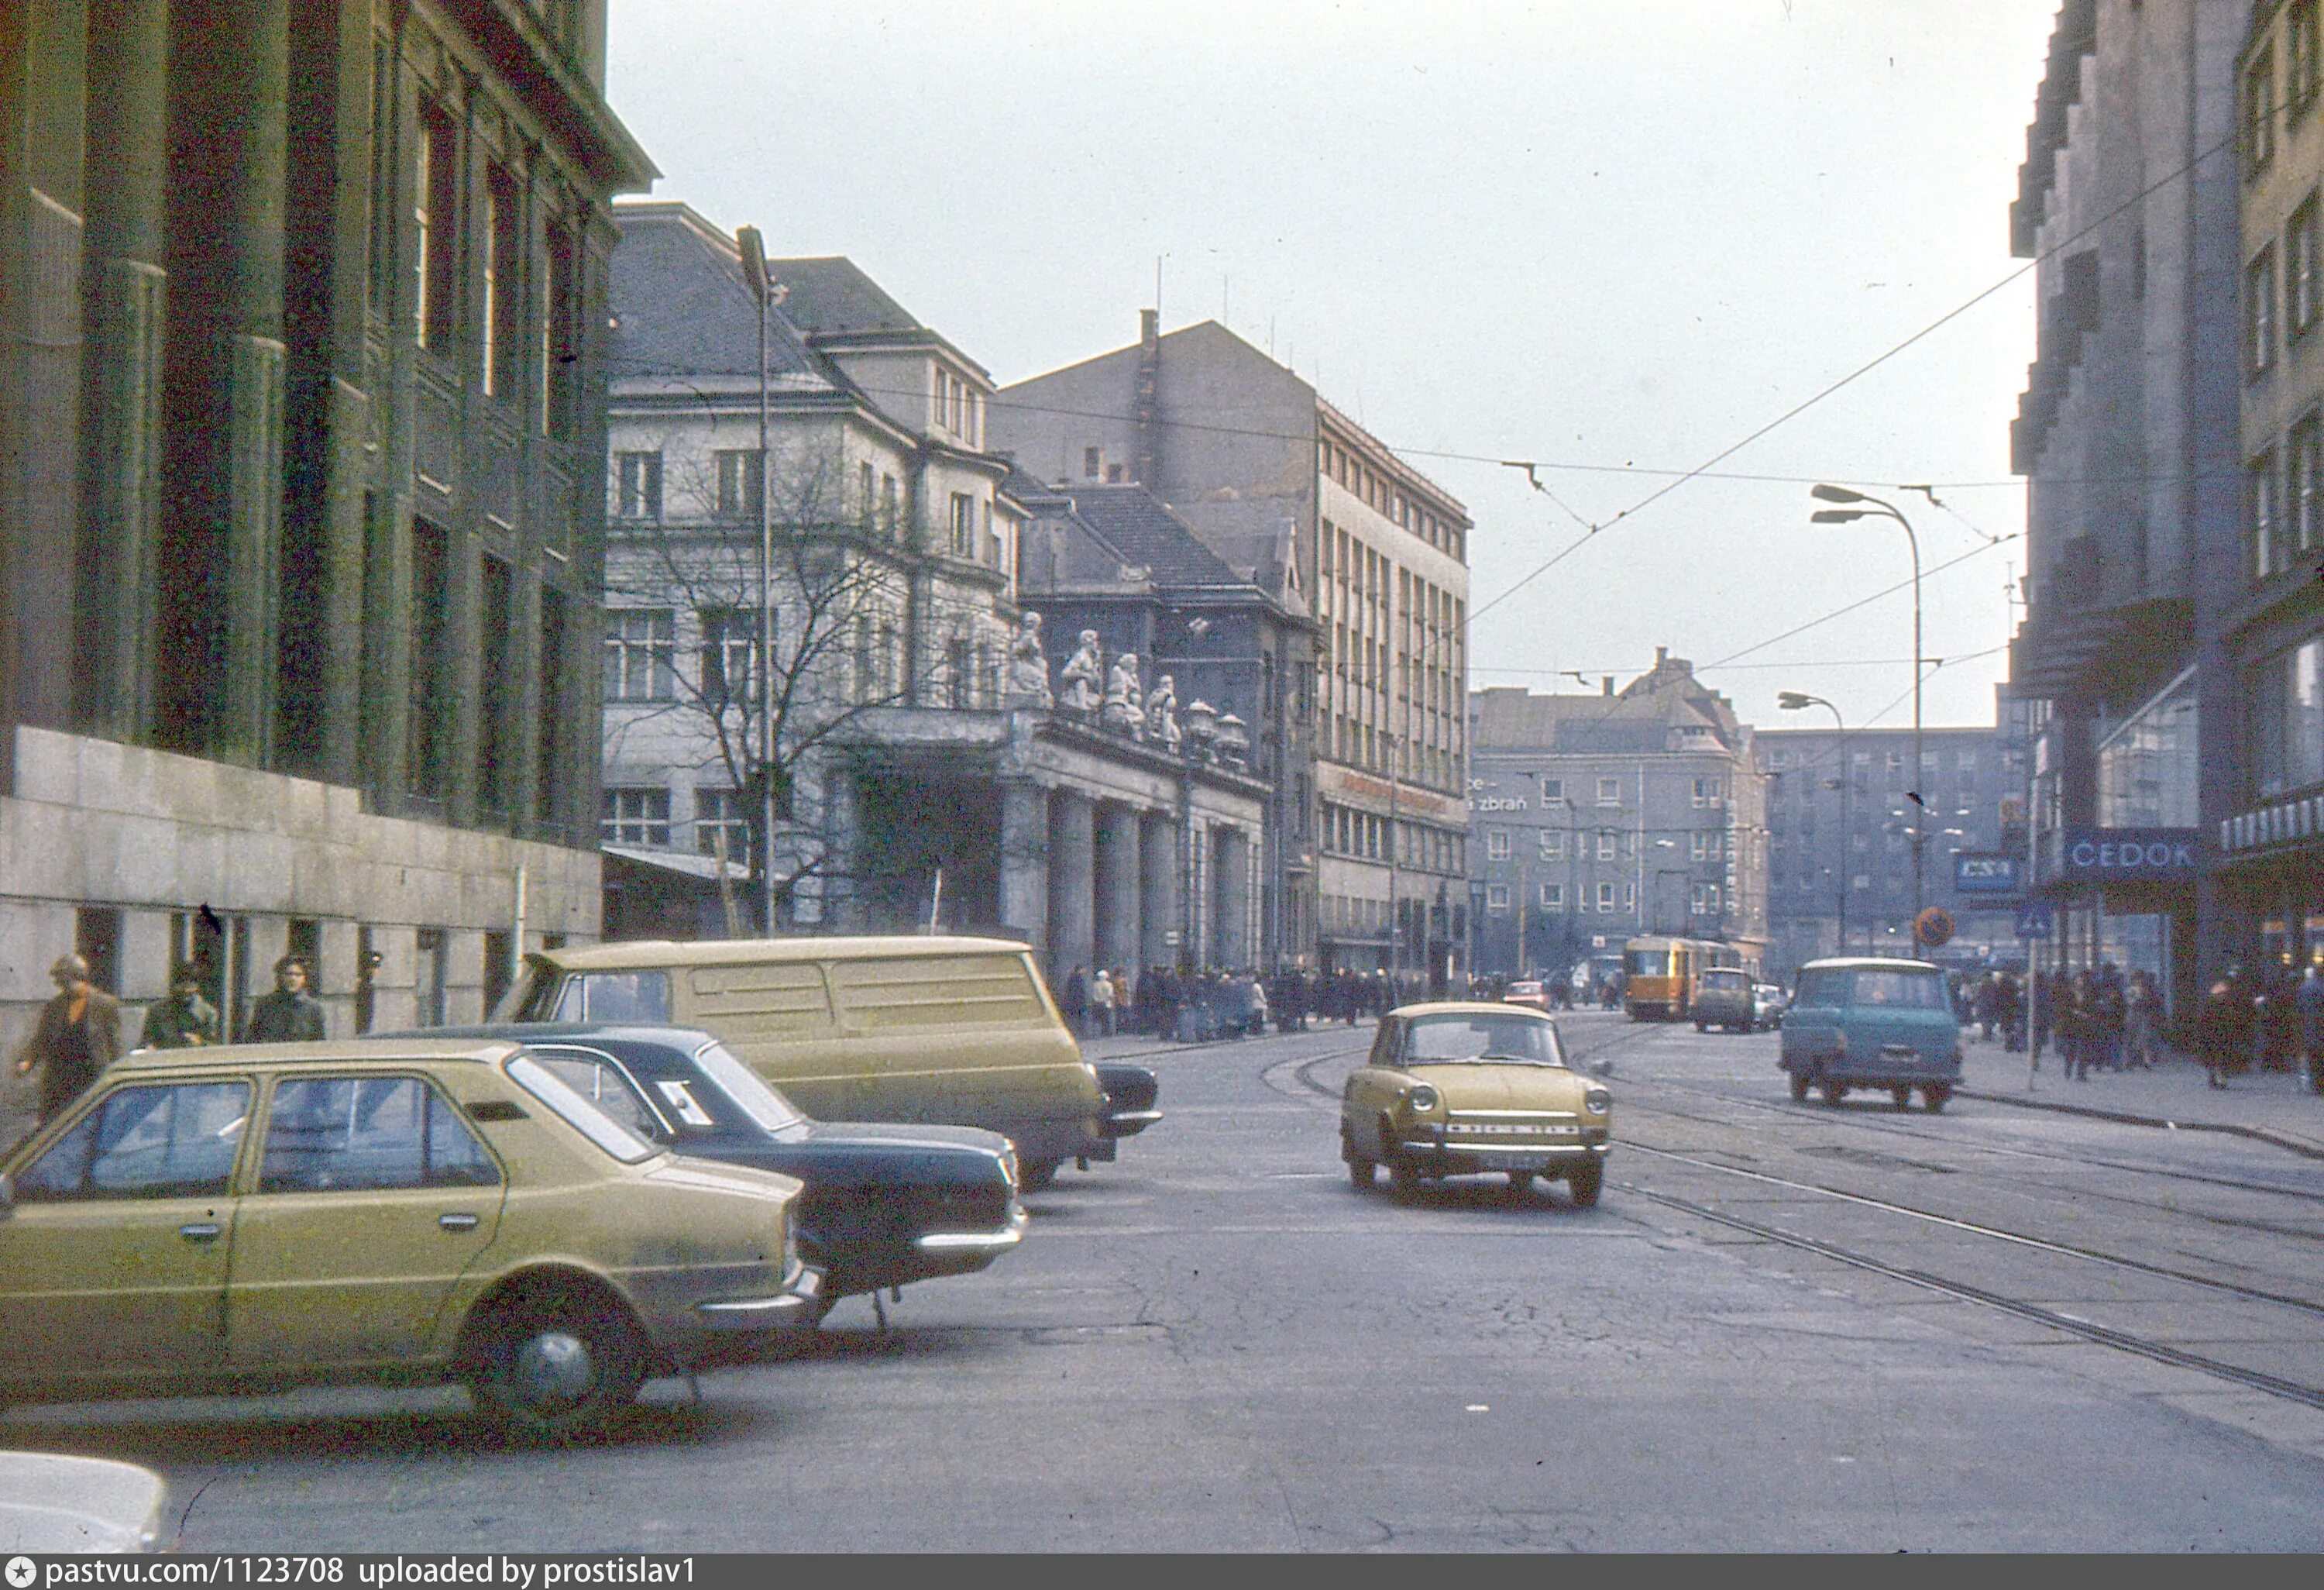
[1778,958,1961,1111]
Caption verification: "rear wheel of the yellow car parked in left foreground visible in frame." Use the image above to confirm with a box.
[467,1292,646,1441]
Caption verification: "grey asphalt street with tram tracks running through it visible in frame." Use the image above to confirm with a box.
[0,1014,2324,1553]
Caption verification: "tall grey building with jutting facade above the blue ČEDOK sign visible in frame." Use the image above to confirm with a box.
[2010,0,2240,1014]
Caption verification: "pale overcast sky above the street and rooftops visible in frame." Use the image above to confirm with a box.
[607,0,2057,725]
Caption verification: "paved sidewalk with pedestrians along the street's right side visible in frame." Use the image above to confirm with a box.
[1959,1027,2324,1160]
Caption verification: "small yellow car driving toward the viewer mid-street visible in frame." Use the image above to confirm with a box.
[1339,1002,1613,1206]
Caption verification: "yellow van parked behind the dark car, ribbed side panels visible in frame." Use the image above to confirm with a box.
[495,937,1113,1188]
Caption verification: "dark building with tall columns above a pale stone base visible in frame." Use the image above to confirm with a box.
[0,0,653,1144]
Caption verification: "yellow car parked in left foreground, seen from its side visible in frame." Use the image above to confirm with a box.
[0,1039,820,1437]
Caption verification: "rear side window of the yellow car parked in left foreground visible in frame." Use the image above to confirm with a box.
[258,1076,500,1192]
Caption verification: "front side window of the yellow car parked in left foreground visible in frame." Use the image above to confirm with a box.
[16,1081,251,1204]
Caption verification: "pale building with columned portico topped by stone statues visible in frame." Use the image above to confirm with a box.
[590,205,1264,979]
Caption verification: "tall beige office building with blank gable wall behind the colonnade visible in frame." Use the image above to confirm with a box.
[992,311,1471,986]
